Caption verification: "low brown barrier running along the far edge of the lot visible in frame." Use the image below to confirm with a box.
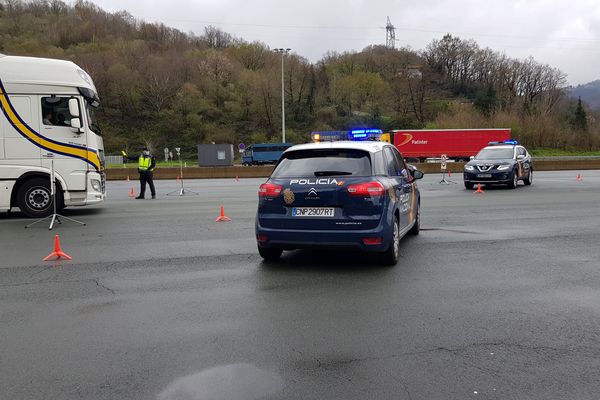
[106,157,600,180]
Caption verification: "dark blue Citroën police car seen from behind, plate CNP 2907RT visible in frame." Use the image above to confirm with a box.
[256,141,423,265]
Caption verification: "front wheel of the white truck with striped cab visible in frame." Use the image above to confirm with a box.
[17,178,63,218]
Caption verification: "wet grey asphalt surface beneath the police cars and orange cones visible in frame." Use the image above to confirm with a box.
[0,171,600,400]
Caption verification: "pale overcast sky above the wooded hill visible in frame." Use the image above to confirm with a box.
[94,0,600,84]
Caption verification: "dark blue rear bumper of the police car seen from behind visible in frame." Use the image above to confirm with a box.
[256,221,392,252]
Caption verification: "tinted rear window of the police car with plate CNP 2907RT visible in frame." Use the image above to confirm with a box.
[272,149,371,178]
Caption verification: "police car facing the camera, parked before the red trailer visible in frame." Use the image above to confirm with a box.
[463,140,533,189]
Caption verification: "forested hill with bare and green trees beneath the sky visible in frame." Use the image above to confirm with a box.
[0,0,599,153]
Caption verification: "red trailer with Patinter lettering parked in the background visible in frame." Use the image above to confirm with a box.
[390,128,511,160]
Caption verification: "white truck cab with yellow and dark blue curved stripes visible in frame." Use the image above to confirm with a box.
[0,54,106,217]
